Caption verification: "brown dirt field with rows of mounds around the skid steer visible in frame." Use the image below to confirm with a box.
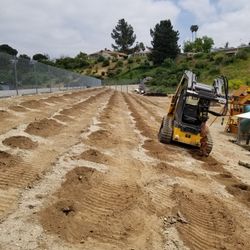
[0,88,250,250]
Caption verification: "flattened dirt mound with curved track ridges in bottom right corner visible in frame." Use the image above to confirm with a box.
[173,187,247,250]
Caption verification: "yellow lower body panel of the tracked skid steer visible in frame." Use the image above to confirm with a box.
[172,127,201,147]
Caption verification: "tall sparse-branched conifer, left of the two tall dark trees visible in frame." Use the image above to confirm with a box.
[111,19,136,53]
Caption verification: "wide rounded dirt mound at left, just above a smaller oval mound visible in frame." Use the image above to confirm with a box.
[25,118,63,137]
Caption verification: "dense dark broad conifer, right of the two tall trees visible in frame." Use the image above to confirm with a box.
[150,20,180,64]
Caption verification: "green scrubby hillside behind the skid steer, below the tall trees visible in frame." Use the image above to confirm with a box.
[88,48,250,91]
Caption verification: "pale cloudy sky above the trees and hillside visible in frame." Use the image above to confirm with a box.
[0,0,250,58]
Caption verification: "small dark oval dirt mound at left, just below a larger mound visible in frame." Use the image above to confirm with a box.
[3,136,38,149]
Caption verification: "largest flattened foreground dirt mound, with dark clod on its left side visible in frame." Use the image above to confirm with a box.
[40,168,150,249]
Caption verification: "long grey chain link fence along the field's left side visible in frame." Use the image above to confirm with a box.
[0,53,102,97]
